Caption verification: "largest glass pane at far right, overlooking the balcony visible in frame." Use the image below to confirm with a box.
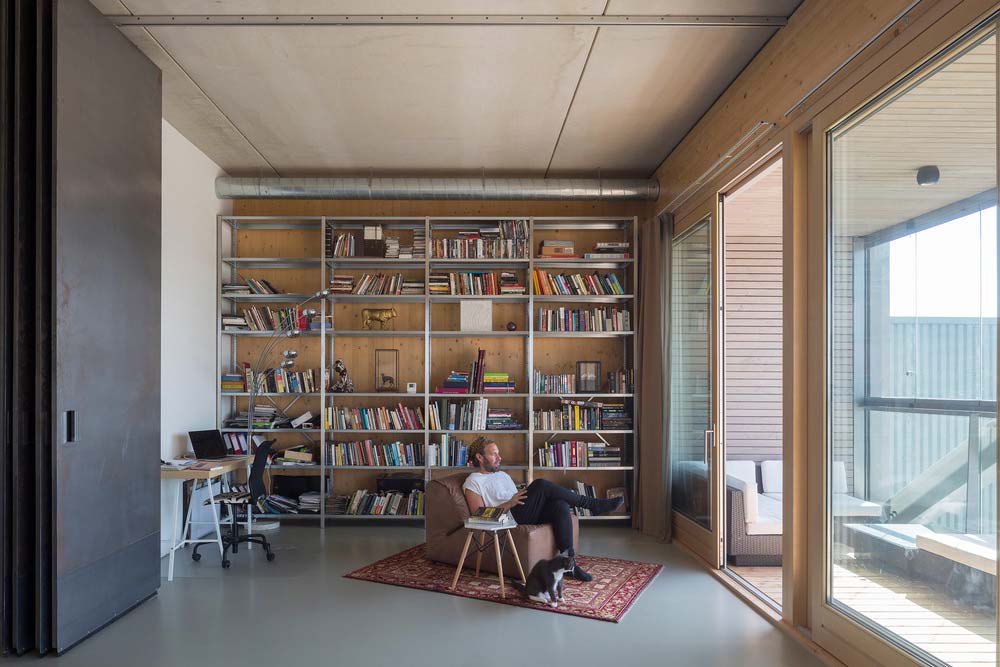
[827,26,997,665]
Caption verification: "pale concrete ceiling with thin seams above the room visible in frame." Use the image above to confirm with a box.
[92,0,799,177]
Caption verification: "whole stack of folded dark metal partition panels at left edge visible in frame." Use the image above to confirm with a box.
[0,0,161,655]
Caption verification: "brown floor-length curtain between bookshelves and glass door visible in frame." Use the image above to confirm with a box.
[632,214,674,540]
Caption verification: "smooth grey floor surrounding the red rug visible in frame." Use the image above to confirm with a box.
[45,524,821,667]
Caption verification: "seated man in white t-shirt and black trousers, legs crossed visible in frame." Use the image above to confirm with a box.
[462,437,622,581]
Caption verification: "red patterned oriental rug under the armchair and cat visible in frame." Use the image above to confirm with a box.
[344,544,663,623]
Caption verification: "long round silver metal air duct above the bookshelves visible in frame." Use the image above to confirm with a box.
[215,176,660,201]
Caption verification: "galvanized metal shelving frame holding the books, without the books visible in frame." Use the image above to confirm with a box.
[216,216,638,525]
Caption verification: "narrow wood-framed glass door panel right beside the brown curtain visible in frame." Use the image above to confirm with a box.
[670,218,717,544]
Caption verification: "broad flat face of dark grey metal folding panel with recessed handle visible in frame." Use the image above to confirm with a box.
[53,0,161,651]
